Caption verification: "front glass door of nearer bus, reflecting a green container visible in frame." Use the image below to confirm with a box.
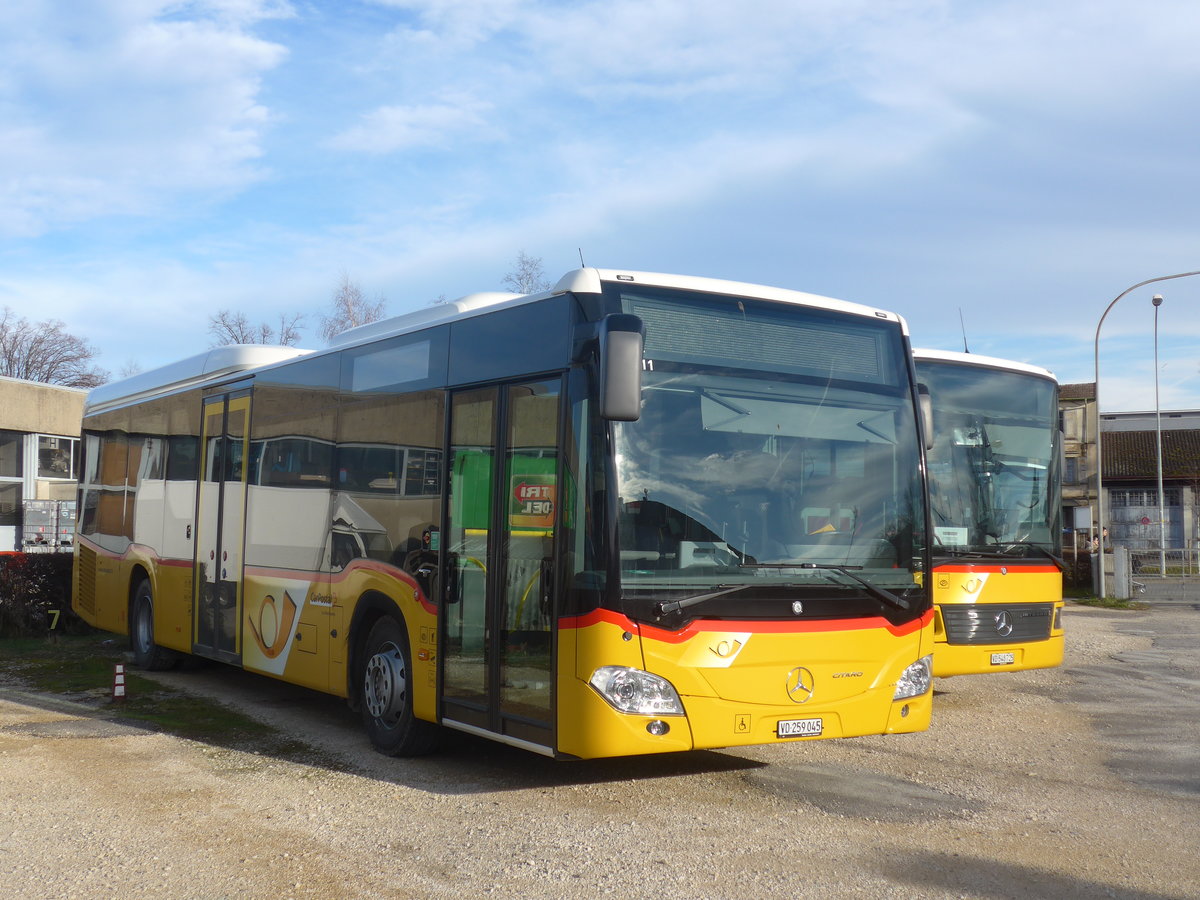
[442,379,560,749]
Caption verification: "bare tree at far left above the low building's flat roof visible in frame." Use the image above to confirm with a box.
[0,306,108,388]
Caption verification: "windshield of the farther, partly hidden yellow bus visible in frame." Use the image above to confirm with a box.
[917,359,1061,557]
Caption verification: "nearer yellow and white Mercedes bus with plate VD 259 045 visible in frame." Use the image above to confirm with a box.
[74,269,932,758]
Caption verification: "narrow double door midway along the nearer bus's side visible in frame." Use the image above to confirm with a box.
[192,391,250,662]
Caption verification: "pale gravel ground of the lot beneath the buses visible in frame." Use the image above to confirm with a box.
[0,601,1200,900]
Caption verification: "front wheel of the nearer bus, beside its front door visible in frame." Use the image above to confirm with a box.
[361,616,438,756]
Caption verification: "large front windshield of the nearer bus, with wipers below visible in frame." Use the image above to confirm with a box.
[614,288,925,614]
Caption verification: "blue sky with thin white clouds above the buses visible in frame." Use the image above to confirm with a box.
[0,0,1200,412]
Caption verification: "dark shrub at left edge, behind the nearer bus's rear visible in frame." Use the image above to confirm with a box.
[0,553,91,637]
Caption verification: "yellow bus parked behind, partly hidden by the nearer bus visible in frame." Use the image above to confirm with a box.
[913,349,1066,677]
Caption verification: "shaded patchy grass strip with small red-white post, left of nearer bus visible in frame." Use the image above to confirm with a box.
[0,634,330,764]
